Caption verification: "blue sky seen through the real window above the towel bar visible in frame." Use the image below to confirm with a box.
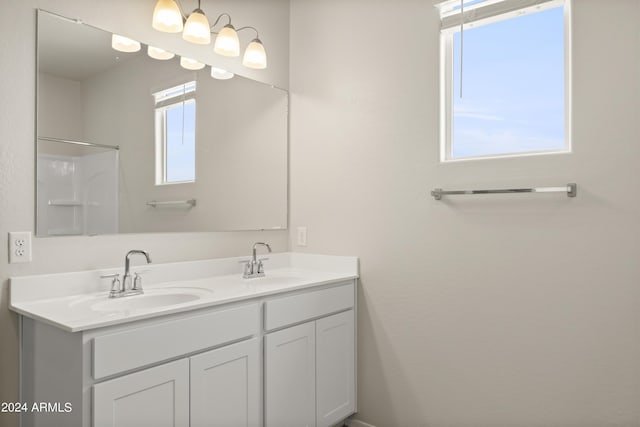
[452,7,565,158]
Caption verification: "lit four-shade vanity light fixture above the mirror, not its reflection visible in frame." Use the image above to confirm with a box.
[152,0,267,70]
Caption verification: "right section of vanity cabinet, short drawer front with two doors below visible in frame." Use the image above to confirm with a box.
[264,283,355,427]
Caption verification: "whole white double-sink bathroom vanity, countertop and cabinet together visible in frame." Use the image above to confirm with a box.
[11,253,358,427]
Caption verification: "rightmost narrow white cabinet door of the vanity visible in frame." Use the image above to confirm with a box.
[316,310,355,427]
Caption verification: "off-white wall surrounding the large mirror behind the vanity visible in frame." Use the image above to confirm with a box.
[0,0,289,427]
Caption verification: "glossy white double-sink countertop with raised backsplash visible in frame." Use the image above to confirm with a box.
[10,253,358,332]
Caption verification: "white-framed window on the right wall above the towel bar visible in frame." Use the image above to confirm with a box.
[439,0,570,161]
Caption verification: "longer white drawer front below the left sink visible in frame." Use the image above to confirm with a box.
[93,303,260,380]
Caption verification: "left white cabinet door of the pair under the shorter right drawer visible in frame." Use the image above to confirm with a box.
[264,322,316,427]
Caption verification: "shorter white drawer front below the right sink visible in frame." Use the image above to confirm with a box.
[264,281,355,331]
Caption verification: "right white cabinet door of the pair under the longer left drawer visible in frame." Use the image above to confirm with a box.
[190,338,261,427]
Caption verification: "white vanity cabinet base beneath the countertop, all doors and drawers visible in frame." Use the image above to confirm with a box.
[22,280,356,427]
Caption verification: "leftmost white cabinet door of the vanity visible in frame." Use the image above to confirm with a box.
[93,360,189,427]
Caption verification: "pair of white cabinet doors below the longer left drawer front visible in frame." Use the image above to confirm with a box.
[93,338,261,427]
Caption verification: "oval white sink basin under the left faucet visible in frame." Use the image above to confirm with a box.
[70,287,213,312]
